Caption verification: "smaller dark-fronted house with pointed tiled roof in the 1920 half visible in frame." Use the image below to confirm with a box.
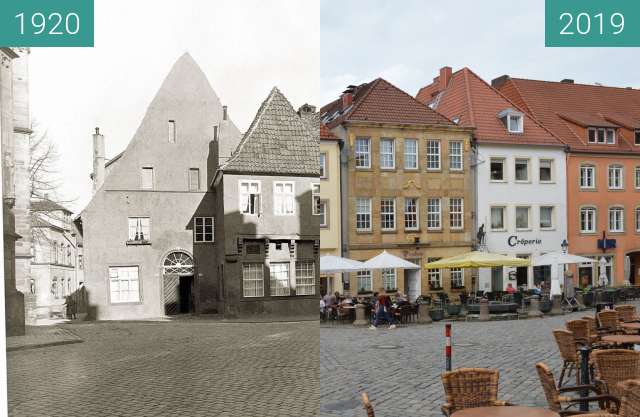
[211,88,320,315]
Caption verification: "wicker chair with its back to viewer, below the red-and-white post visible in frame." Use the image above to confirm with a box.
[442,368,509,417]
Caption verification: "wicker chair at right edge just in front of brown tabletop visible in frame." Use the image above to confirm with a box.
[591,349,640,398]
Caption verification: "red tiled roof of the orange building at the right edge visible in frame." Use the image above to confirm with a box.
[498,77,640,153]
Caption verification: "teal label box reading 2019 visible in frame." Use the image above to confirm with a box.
[545,0,640,47]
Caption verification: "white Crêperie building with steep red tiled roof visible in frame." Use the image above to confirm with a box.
[417,67,567,291]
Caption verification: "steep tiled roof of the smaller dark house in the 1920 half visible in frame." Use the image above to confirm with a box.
[220,87,320,176]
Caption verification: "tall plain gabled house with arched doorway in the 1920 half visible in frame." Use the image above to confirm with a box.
[77,54,240,319]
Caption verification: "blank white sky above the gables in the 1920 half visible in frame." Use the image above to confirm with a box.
[30,0,320,212]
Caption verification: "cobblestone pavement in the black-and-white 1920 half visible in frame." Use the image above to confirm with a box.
[7,321,319,417]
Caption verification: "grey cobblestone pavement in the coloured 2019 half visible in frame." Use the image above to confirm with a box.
[320,303,637,417]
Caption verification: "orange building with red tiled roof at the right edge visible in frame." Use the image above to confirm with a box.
[492,75,640,285]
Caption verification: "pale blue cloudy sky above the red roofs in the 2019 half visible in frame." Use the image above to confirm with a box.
[320,0,640,104]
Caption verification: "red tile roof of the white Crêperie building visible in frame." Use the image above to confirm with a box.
[418,67,564,146]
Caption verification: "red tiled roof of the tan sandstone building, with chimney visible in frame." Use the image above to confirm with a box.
[320,78,455,128]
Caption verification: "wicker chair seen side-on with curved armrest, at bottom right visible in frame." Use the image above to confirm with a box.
[536,362,617,416]
